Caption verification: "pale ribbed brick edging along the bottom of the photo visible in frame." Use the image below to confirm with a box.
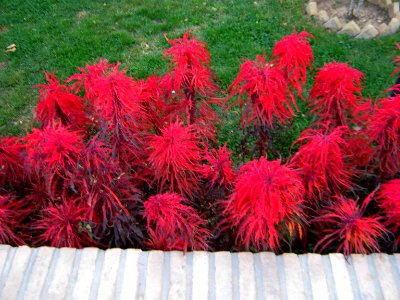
[0,245,400,300]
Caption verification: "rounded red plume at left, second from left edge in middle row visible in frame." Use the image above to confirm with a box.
[24,125,83,196]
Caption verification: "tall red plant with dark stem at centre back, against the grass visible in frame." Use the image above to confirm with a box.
[163,32,220,140]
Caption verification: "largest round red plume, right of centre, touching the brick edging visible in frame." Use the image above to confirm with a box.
[222,157,304,251]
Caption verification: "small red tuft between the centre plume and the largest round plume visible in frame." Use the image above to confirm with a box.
[202,144,236,188]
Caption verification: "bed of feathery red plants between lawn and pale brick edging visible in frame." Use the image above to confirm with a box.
[0,32,400,255]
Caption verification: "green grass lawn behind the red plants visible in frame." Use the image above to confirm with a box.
[0,0,399,141]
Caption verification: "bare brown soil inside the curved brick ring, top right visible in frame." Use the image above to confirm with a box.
[317,0,390,28]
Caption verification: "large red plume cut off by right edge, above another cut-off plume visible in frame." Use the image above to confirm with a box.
[367,95,400,176]
